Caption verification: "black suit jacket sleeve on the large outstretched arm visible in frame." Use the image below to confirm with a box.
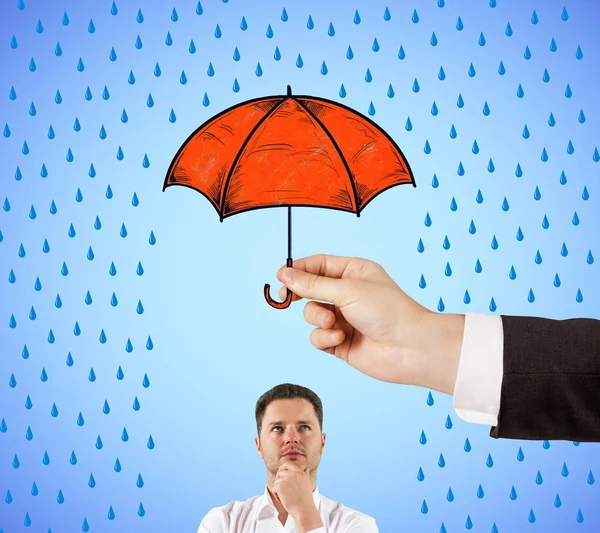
[490,316,600,442]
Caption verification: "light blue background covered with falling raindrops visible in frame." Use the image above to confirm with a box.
[0,0,600,533]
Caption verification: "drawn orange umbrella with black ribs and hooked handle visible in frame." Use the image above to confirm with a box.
[163,85,416,309]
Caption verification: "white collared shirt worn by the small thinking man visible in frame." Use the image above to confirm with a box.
[198,487,379,533]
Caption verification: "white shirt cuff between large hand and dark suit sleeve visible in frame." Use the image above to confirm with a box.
[453,313,504,426]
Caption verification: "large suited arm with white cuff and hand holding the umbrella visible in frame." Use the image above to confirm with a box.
[277,255,600,441]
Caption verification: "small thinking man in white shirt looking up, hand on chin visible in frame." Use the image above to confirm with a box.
[198,383,378,533]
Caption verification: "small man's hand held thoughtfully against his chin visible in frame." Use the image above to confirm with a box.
[273,462,323,533]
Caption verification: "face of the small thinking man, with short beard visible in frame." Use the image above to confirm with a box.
[254,398,326,475]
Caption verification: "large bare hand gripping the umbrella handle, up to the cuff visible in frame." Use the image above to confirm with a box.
[277,255,464,394]
